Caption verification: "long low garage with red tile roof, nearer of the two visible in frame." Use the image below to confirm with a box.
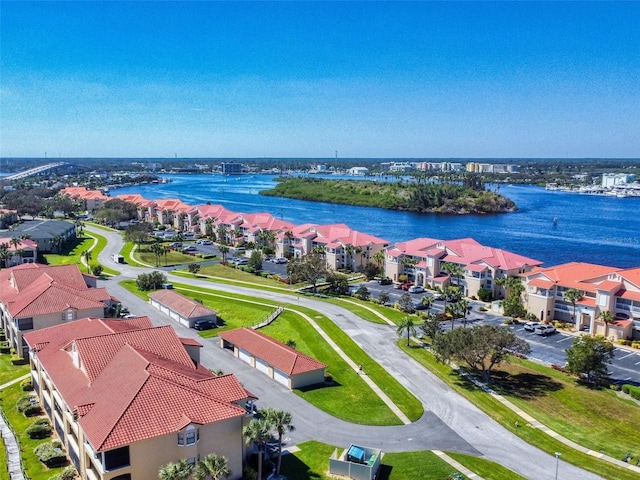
[218,328,327,389]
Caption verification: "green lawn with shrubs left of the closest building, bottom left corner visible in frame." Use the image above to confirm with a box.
[0,383,64,480]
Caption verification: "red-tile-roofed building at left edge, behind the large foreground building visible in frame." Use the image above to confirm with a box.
[0,263,112,356]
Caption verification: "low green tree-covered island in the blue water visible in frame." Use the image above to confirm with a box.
[260,175,517,215]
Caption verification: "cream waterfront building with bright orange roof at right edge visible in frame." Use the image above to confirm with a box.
[522,262,640,340]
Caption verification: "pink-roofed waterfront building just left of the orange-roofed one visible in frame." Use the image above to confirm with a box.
[385,238,542,298]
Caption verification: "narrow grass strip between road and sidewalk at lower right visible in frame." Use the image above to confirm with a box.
[398,340,638,480]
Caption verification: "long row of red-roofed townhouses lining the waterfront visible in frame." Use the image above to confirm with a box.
[57,186,640,339]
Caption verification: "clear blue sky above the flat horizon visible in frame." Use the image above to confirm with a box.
[0,0,640,158]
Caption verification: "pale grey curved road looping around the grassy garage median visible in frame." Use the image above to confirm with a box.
[90,227,601,480]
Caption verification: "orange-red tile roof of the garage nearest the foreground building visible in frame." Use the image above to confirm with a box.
[219,328,327,375]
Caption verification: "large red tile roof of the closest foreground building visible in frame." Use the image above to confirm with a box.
[25,317,256,451]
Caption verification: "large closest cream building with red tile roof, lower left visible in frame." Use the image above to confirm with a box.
[25,317,256,480]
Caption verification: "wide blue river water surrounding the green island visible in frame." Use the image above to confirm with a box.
[112,175,640,268]
